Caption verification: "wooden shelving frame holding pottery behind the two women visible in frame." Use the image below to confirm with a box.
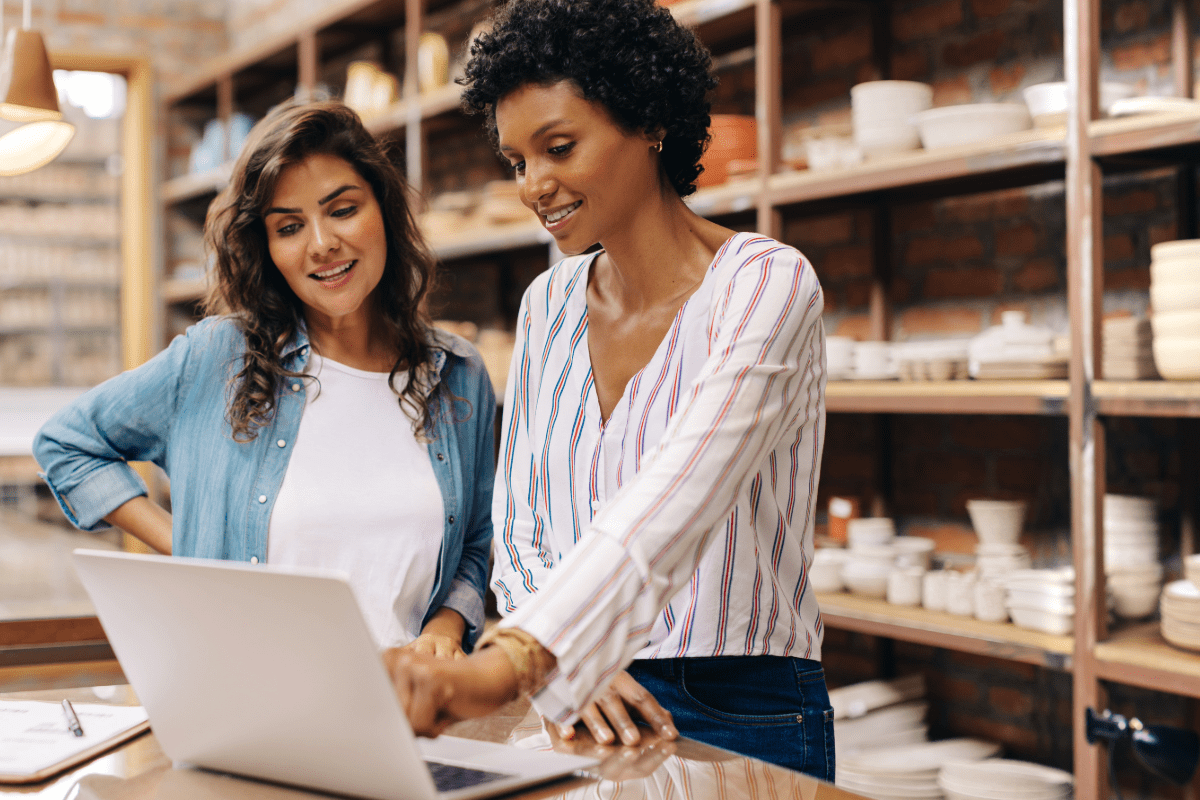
[154,0,1200,798]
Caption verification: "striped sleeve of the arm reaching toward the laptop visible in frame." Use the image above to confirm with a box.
[502,248,823,722]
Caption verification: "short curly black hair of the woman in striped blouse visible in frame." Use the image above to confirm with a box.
[458,0,716,197]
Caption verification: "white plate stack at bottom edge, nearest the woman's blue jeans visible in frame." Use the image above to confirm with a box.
[834,739,1000,800]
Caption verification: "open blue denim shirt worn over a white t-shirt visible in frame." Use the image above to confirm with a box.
[34,317,496,646]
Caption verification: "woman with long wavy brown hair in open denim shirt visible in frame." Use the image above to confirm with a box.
[35,102,496,657]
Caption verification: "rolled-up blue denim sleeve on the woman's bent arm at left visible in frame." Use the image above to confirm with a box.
[34,324,208,531]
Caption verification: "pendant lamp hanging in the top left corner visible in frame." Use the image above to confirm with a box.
[0,0,74,175]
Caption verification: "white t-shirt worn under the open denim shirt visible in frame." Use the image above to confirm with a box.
[266,353,444,648]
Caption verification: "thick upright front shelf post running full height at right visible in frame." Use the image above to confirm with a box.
[1063,0,1108,798]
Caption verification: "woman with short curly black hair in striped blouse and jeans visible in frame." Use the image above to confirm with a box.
[392,0,834,778]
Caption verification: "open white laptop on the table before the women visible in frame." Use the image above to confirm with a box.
[74,549,596,800]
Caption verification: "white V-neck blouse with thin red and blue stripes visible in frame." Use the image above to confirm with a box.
[492,234,826,722]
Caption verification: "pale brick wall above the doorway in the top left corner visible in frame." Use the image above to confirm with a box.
[0,0,227,89]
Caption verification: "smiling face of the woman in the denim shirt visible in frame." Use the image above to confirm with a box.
[263,154,388,327]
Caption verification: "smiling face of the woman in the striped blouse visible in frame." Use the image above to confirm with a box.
[496,80,661,254]
